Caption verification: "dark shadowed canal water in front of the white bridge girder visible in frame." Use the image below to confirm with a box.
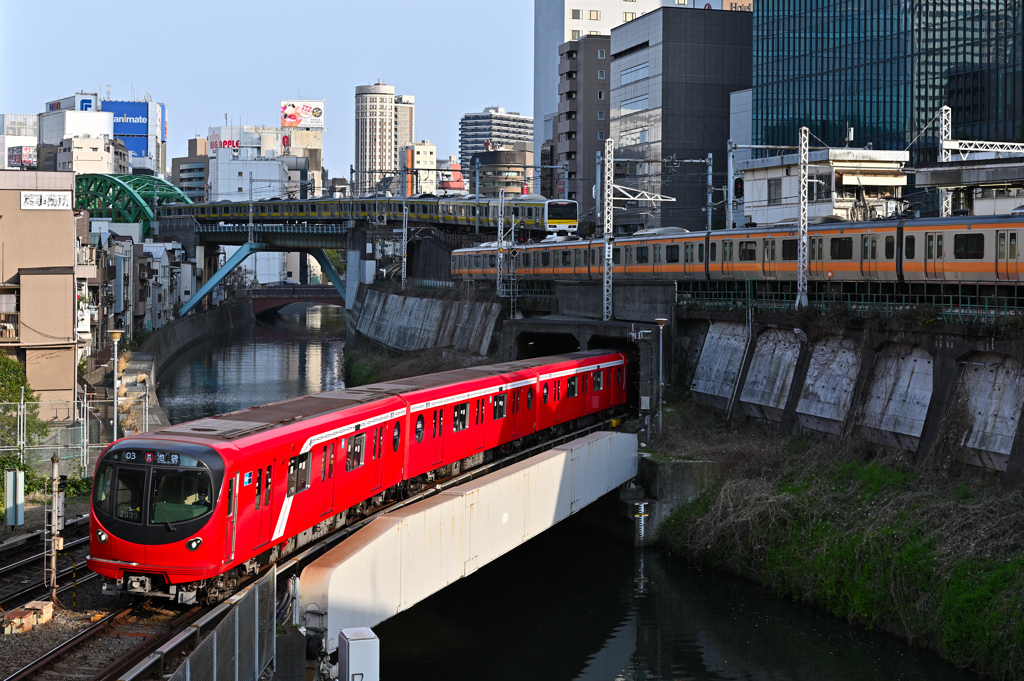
[374,522,978,681]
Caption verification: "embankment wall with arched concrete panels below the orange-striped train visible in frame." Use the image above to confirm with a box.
[677,320,1024,486]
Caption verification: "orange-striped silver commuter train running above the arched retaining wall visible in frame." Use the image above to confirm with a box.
[452,215,1024,283]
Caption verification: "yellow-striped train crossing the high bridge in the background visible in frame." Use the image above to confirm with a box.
[160,194,580,237]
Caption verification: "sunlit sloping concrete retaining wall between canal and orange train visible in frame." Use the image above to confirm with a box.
[354,288,502,356]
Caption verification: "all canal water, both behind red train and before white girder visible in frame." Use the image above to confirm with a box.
[159,305,978,681]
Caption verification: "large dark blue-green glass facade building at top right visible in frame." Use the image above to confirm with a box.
[753,0,1024,163]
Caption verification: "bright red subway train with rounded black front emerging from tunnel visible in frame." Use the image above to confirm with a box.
[88,350,636,603]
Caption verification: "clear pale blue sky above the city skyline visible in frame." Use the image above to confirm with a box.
[0,0,534,177]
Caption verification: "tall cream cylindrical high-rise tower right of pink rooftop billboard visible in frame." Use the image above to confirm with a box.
[353,81,416,196]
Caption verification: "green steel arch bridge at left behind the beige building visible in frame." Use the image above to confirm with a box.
[75,174,191,237]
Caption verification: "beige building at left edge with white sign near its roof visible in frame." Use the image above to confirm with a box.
[0,170,79,403]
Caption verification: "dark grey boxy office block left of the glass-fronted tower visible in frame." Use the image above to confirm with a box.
[610,7,752,231]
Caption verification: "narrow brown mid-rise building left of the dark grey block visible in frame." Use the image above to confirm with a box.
[549,36,611,229]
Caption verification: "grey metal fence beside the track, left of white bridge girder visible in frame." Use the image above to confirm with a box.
[170,567,278,681]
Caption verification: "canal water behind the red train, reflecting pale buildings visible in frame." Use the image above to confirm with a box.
[158,303,345,423]
